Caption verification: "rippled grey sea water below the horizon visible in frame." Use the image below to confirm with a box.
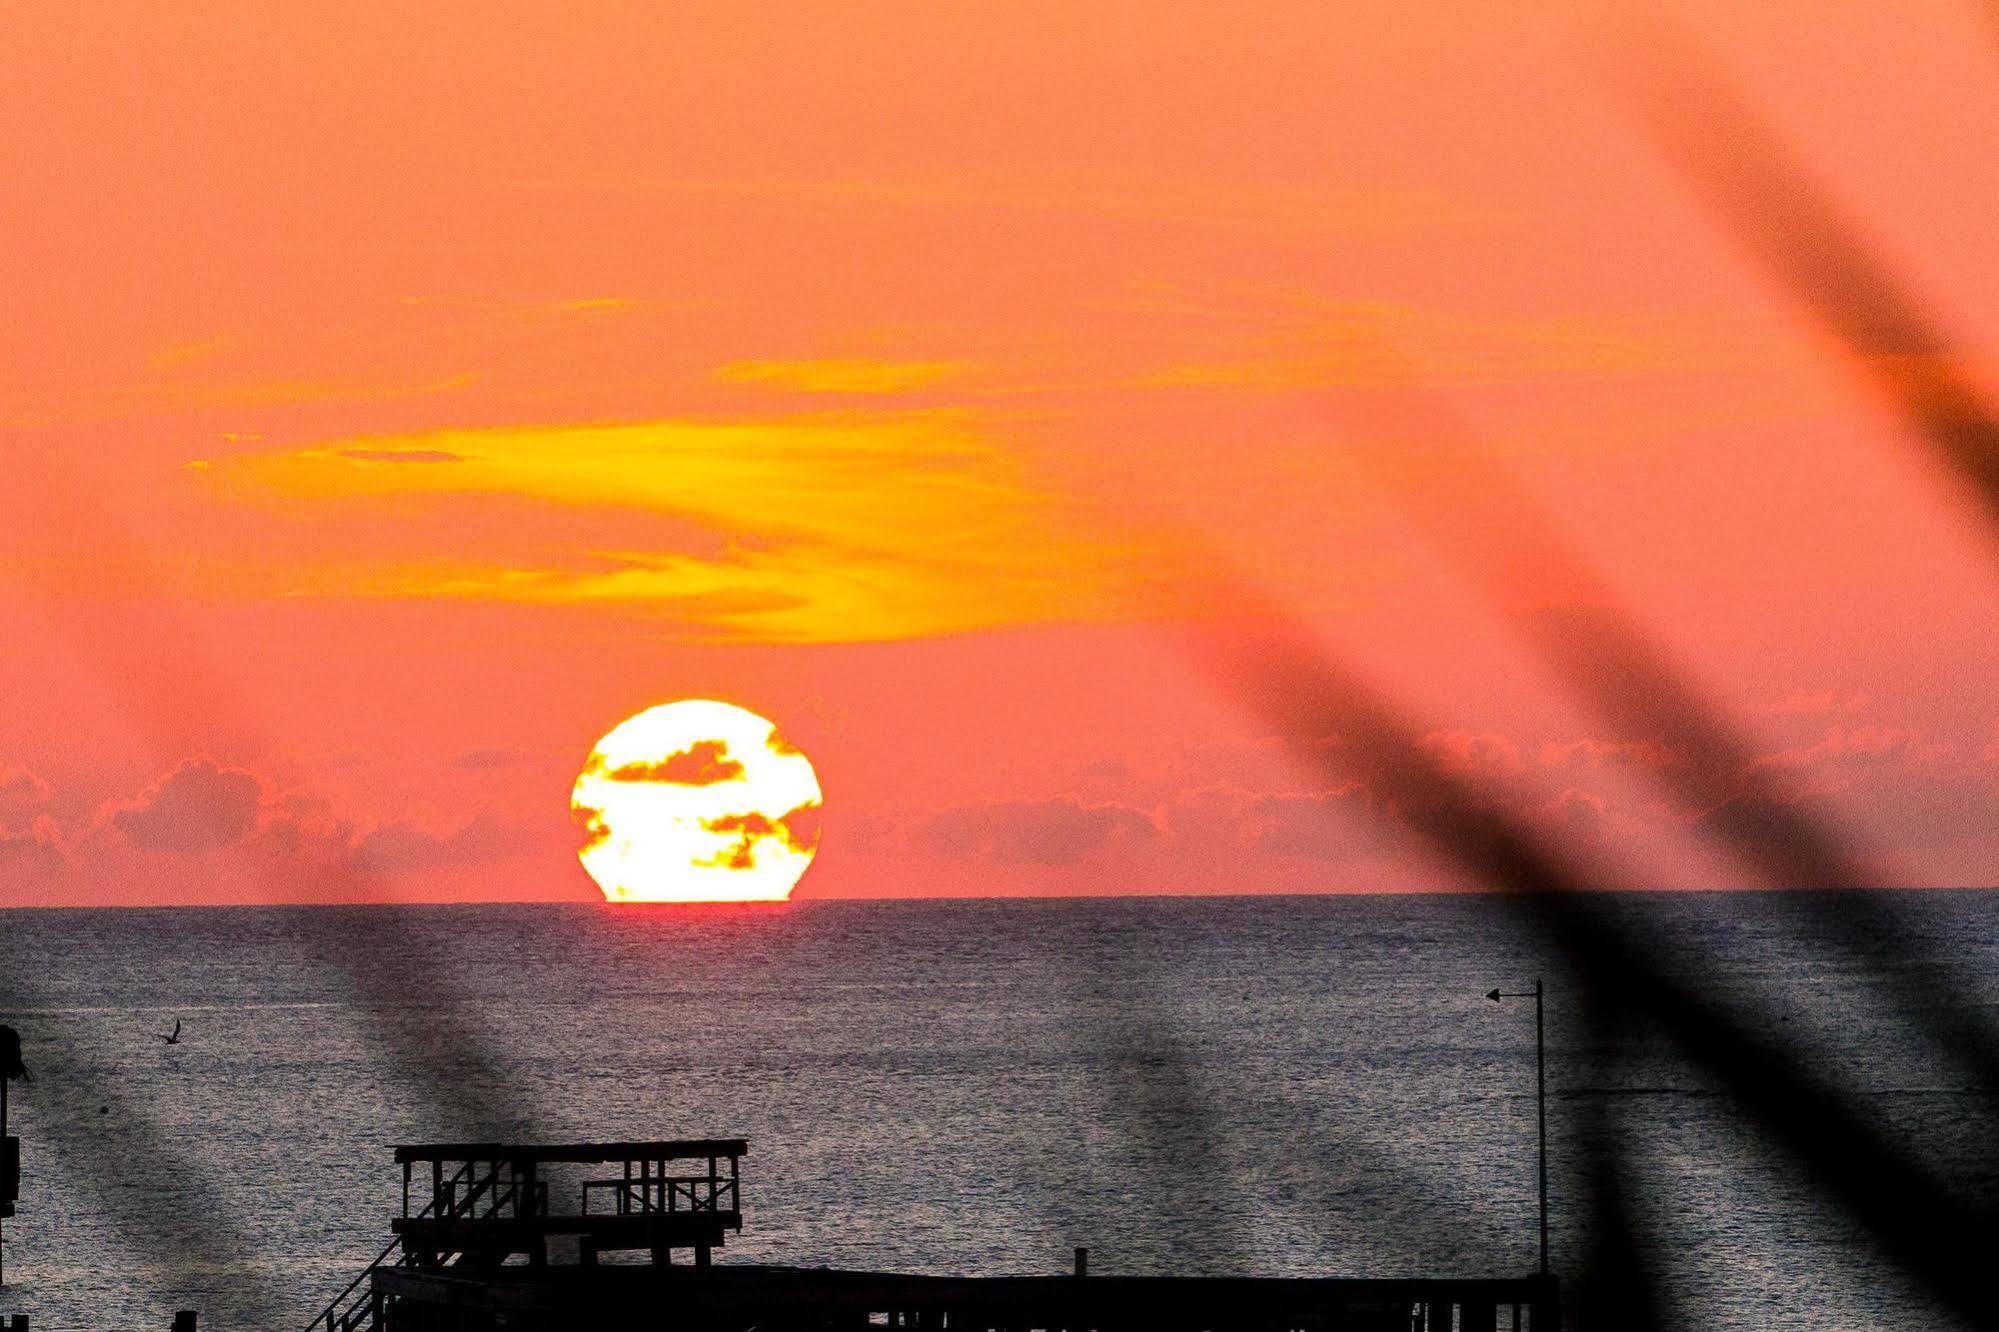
[0,892,1999,1332]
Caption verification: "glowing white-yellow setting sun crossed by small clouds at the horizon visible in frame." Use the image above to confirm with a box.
[570,698,820,902]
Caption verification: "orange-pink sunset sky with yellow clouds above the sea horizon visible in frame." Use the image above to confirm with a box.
[0,0,1999,904]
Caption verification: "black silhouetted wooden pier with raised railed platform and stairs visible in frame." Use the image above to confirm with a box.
[308,1138,1561,1332]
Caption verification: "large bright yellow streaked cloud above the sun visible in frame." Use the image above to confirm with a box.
[210,412,1131,642]
